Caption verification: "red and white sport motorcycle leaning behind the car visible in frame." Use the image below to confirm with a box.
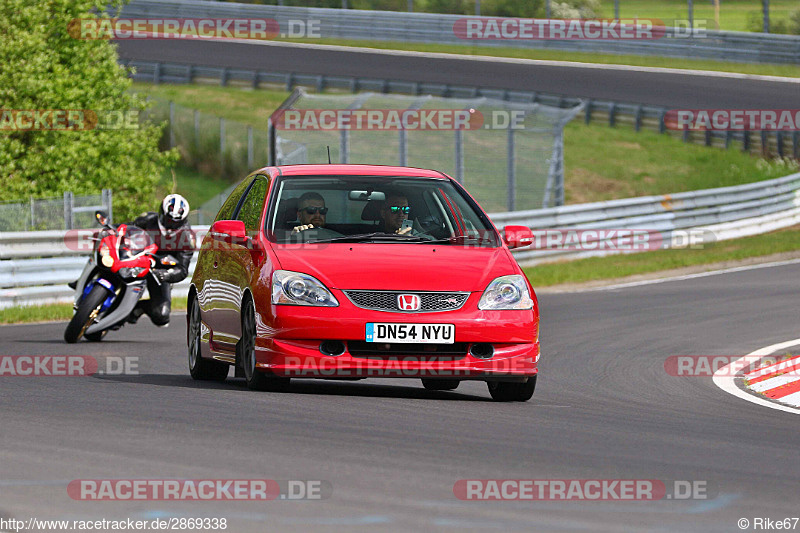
[64,211,163,343]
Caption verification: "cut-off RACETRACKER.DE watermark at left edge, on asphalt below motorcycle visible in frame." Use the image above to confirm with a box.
[0,355,139,377]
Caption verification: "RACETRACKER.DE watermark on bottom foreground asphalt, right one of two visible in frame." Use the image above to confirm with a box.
[453,479,710,502]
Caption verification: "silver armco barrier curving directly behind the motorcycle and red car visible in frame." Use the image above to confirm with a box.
[0,173,800,308]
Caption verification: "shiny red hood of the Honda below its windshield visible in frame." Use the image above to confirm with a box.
[273,243,518,291]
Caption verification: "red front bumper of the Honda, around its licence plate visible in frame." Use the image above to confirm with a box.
[256,293,539,380]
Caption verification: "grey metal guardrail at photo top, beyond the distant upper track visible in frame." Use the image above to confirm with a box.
[122,0,800,64]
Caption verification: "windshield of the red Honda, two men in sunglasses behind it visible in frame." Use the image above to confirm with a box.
[266,176,499,247]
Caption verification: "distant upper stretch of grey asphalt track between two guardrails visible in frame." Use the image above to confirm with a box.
[117,40,800,109]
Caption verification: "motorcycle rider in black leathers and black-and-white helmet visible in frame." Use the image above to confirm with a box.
[128,194,195,327]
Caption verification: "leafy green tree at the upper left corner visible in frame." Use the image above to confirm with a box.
[0,0,177,220]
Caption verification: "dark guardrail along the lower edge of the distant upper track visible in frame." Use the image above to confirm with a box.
[122,61,800,158]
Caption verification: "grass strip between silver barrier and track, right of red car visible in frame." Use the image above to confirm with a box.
[524,222,800,288]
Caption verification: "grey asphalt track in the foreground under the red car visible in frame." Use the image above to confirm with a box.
[0,265,800,532]
